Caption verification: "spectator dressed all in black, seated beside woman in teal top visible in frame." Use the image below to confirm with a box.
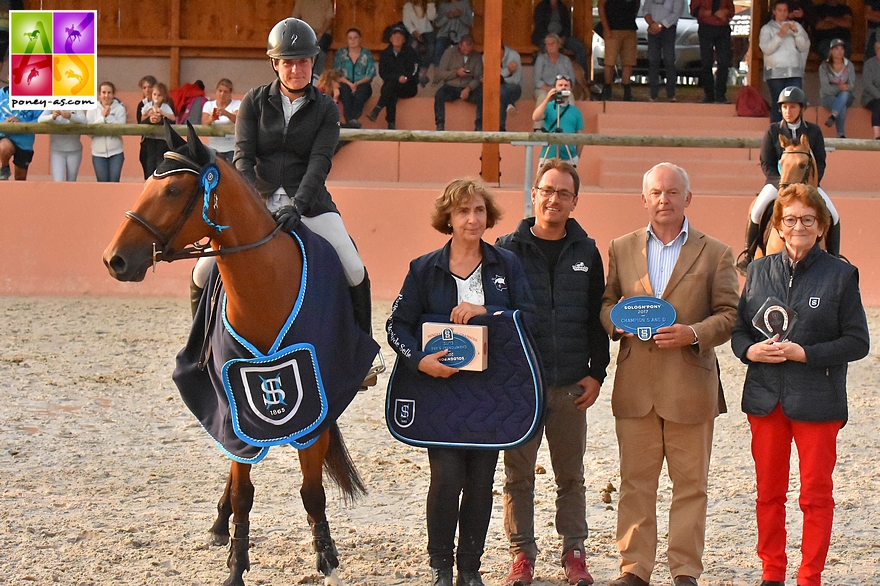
[367,25,419,130]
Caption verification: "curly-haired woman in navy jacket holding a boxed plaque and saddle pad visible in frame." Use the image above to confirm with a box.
[386,179,534,586]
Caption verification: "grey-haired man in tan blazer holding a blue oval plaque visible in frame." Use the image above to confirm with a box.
[601,163,739,586]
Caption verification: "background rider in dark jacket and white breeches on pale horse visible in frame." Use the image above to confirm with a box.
[736,86,840,274]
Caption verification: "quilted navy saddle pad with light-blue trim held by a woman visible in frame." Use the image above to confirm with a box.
[385,310,544,450]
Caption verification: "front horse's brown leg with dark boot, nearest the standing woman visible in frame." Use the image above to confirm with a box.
[299,431,342,586]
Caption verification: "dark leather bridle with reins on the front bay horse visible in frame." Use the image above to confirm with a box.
[125,151,281,272]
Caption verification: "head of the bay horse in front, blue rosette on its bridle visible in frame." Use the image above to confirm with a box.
[104,121,244,281]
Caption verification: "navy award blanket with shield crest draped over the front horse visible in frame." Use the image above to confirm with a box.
[172,226,379,464]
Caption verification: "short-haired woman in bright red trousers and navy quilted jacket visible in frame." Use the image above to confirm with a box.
[731,184,870,586]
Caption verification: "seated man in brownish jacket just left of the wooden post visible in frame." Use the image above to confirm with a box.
[434,35,483,131]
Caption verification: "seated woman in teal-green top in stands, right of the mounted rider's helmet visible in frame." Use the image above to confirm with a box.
[333,28,376,128]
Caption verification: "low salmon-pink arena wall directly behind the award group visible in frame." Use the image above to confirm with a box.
[0,181,880,305]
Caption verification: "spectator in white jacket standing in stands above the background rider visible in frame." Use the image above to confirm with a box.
[759,0,810,124]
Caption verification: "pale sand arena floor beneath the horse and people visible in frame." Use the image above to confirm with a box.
[0,298,880,586]
